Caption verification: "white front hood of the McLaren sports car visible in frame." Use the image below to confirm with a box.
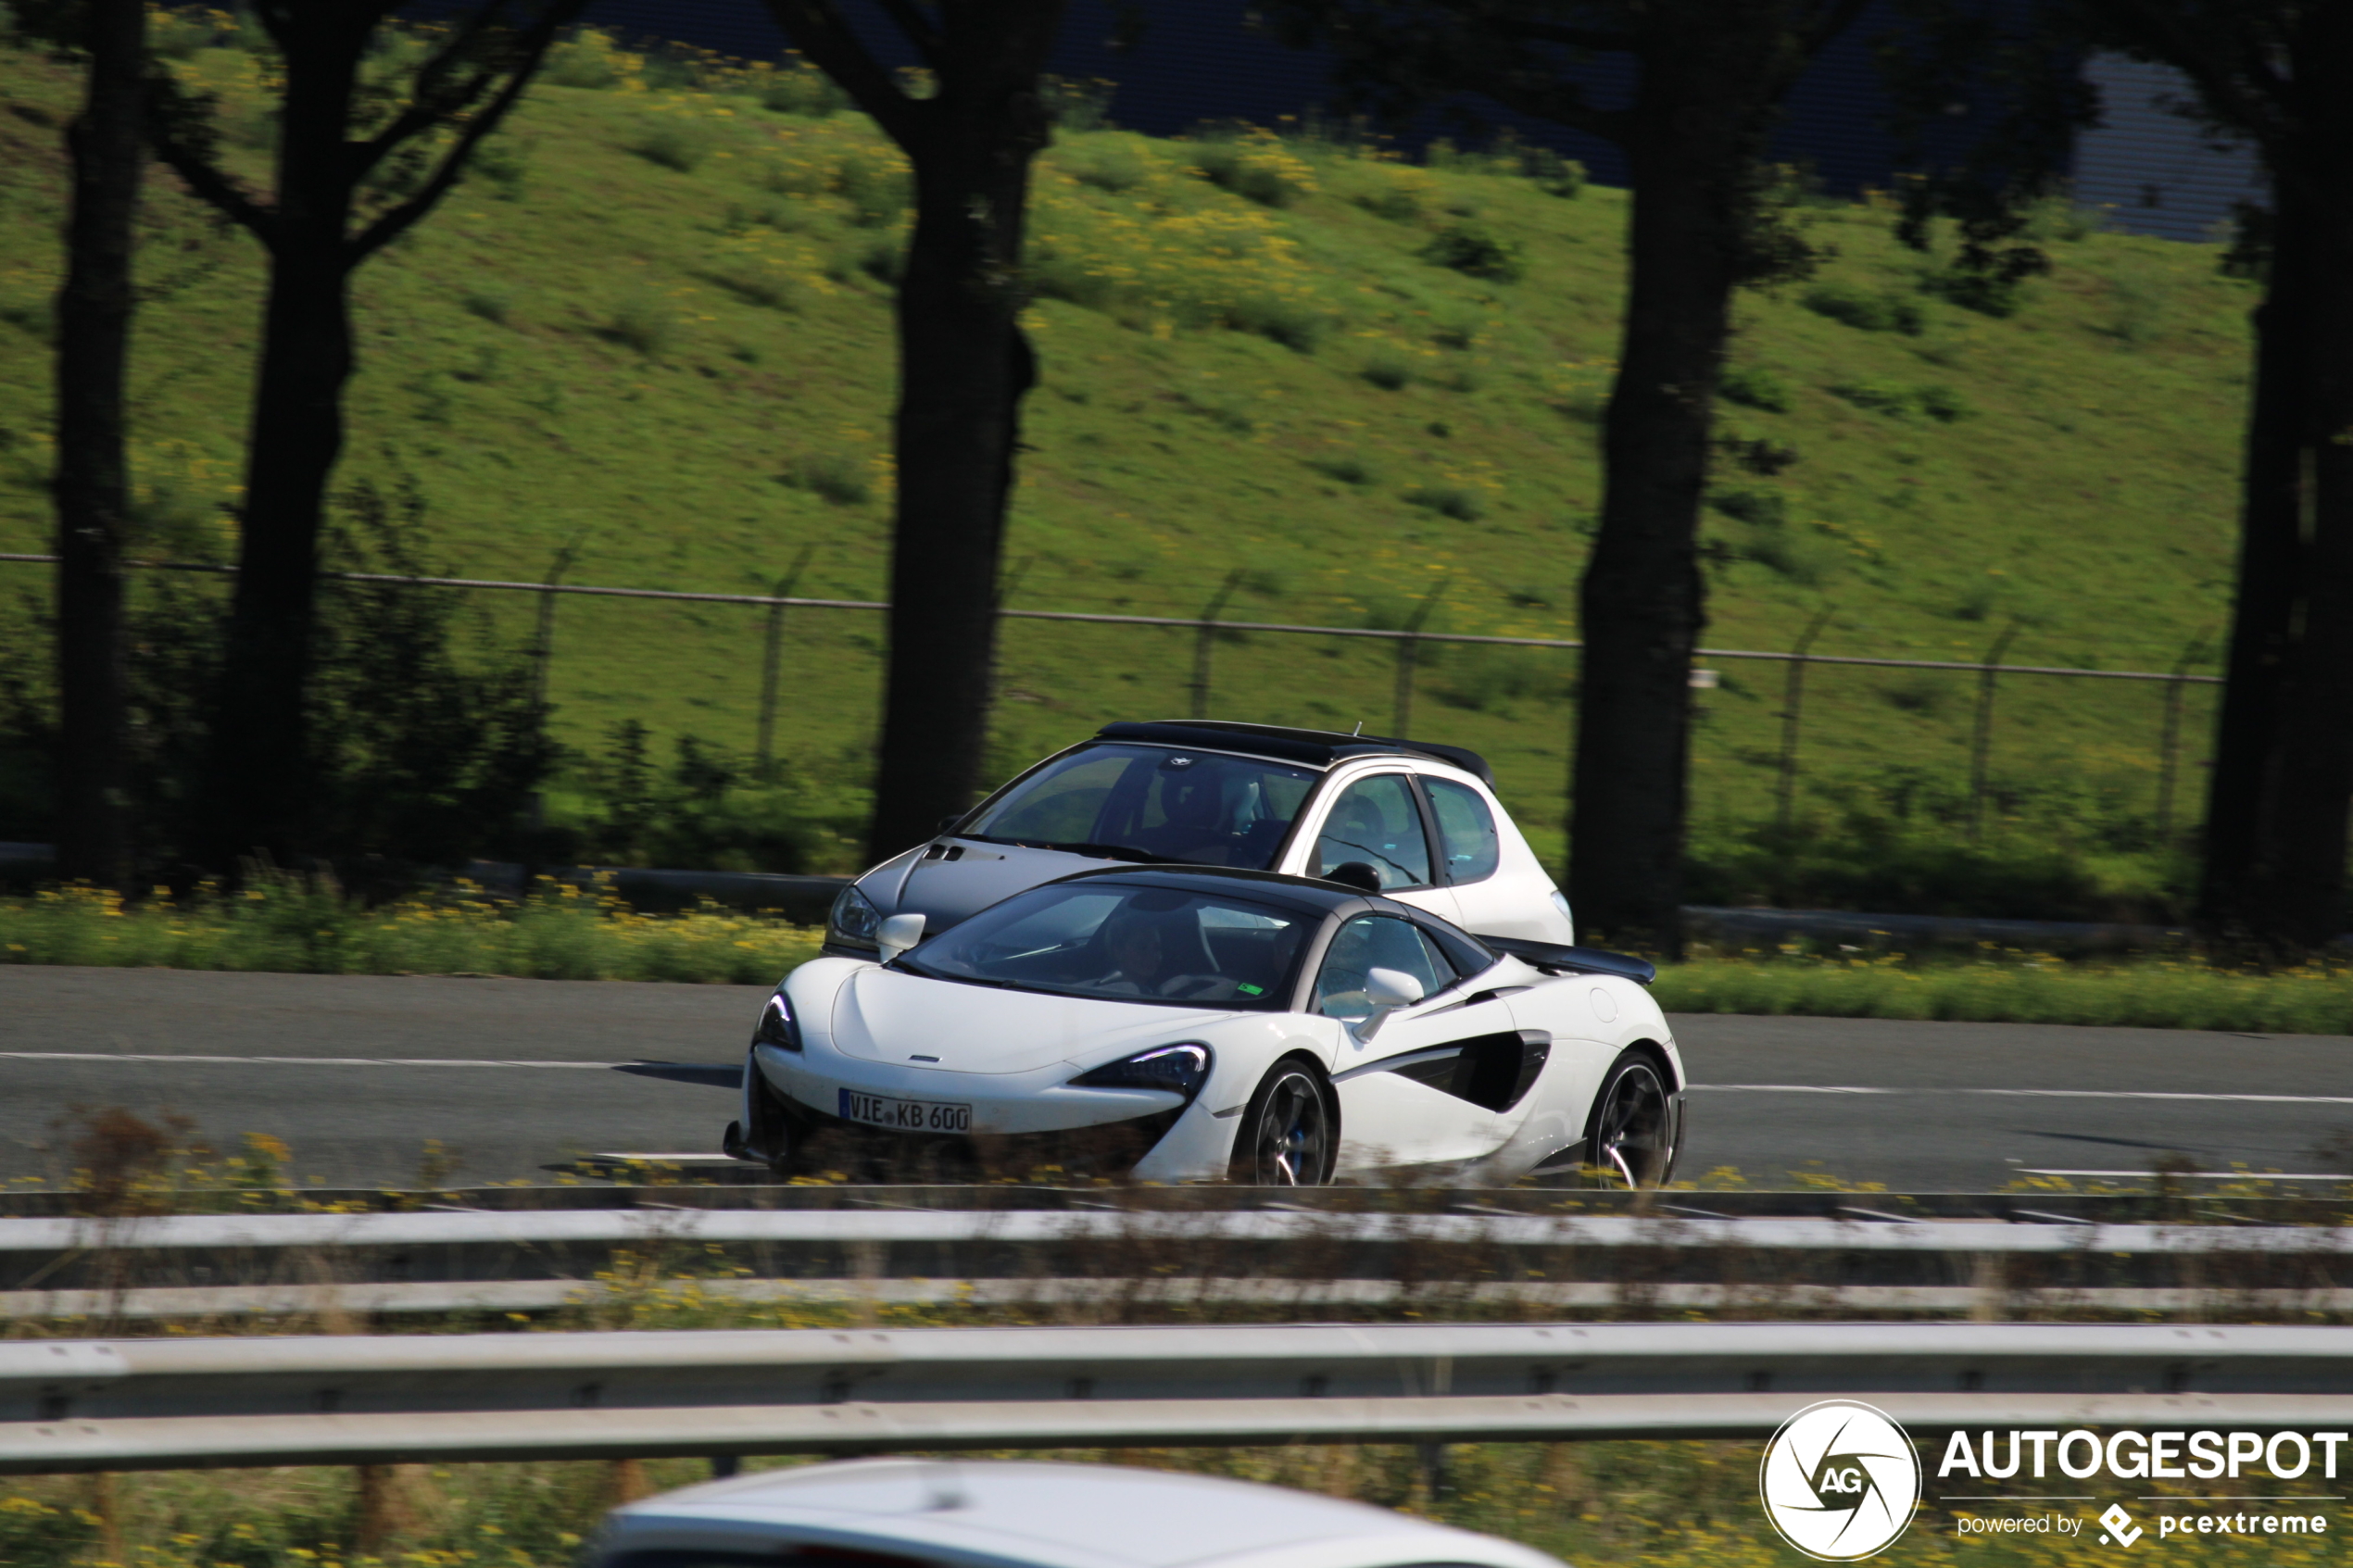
[833,966,1226,1072]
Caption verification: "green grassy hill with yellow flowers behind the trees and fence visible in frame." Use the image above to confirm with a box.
[0,24,2252,912]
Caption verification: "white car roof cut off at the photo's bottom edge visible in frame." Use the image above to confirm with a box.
[598,1460,1563,1568]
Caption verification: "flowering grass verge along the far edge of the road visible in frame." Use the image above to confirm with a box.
[0,877,2353,1035]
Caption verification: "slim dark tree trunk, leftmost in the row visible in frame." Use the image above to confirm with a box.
[57,0,145,888]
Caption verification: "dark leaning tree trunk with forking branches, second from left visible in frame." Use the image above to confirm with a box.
[202,28,365,865]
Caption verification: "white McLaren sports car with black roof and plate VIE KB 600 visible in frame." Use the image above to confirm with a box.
[723,868,1685,1187]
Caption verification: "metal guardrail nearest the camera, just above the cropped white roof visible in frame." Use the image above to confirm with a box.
[0,1323,2353,1474]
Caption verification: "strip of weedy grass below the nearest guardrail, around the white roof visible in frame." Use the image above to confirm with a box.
[0,1441,2330,1568]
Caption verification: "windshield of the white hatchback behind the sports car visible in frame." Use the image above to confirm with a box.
[960,746,1315,872]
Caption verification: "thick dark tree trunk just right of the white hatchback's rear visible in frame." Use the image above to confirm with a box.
[1569,116,1737,955]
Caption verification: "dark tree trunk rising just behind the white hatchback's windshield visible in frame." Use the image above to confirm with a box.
[868,82,1047,858]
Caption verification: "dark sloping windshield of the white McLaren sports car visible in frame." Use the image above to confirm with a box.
[899,879,1315,1010]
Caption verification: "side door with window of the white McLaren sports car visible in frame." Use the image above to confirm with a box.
[1308,914,1546,1169]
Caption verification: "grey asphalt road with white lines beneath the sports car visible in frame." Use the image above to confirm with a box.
[0,966,2353,1192]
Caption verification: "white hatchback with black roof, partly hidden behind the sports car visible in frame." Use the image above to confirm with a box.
[826,720,1577,957]
